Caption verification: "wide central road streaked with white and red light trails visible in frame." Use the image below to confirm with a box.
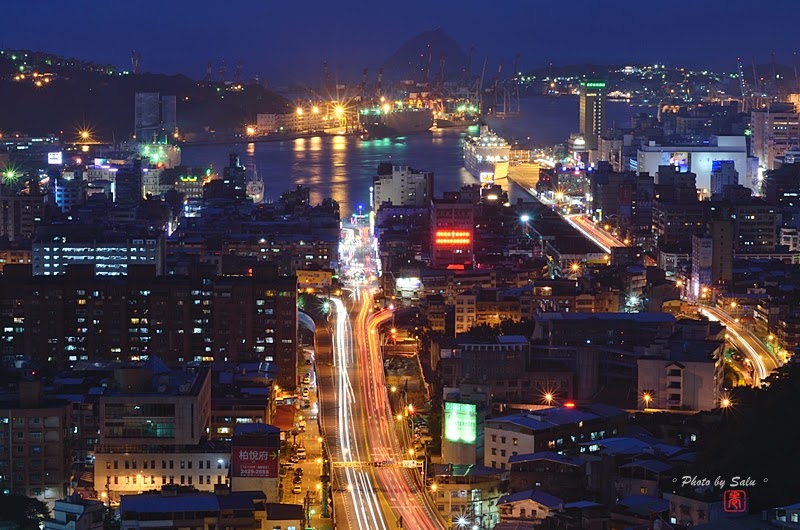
[317,221,445,530]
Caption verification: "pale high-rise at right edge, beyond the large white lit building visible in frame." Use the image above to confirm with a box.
[751,103,800,169]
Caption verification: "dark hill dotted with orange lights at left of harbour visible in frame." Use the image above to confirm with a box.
[0,50,292,140]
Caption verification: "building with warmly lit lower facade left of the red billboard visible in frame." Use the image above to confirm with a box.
[95,357,230,500]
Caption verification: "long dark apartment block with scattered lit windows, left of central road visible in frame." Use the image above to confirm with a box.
[0,262,297,388]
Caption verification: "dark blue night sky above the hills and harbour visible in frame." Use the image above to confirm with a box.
[0,0,800,83]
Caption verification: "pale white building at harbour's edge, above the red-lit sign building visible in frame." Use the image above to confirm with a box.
[372,162,433,211]
